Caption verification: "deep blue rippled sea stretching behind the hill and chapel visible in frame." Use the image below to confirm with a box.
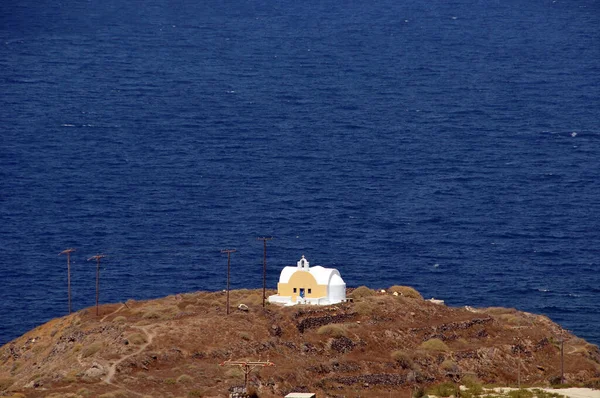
[0,0,600,345]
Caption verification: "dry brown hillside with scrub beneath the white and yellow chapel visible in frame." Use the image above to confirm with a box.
[0,287,600,398]
